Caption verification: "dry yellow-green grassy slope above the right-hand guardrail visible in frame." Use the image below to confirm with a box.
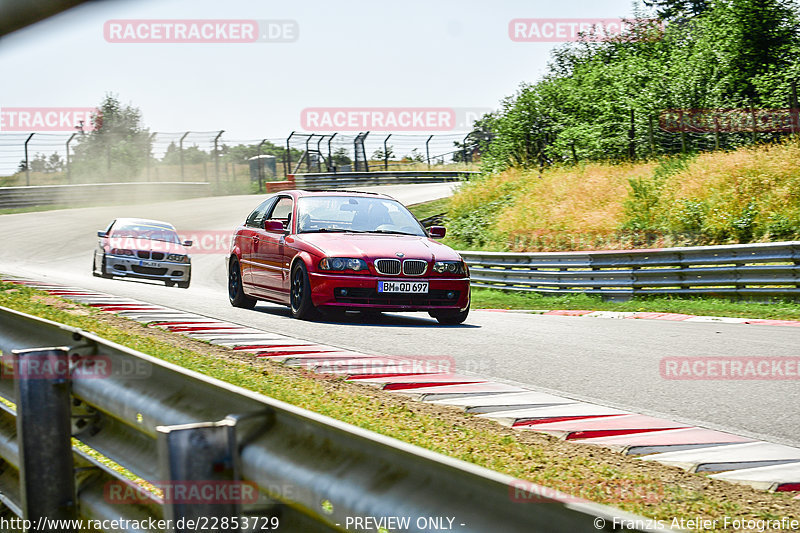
[450,139,800,251]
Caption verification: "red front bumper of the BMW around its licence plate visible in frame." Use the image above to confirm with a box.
[309,272,470,311]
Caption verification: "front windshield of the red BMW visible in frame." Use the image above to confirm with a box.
[297,196,425,237]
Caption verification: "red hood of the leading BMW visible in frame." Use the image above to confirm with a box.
[297,233,460,261]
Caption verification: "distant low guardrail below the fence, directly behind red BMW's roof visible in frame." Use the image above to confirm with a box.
[289,170,472,190]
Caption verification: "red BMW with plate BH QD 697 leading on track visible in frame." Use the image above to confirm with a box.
[228,191,470,324]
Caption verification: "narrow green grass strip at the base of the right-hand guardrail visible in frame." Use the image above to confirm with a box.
[472,289,800,320]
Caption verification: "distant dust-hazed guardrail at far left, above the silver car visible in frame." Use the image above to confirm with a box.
[0,182,211,209]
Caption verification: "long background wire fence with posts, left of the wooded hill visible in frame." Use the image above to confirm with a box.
[0,131,477,193]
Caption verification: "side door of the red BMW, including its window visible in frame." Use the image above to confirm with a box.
[252,196,294,299]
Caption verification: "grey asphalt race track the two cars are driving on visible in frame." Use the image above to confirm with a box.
[0,183,800,446]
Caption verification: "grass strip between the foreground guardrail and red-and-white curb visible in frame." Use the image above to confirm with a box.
[0,283,800,520]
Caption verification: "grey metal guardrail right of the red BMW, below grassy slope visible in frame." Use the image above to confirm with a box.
[459,242,800,299]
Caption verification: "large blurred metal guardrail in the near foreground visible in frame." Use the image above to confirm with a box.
[0,307,658,533]
